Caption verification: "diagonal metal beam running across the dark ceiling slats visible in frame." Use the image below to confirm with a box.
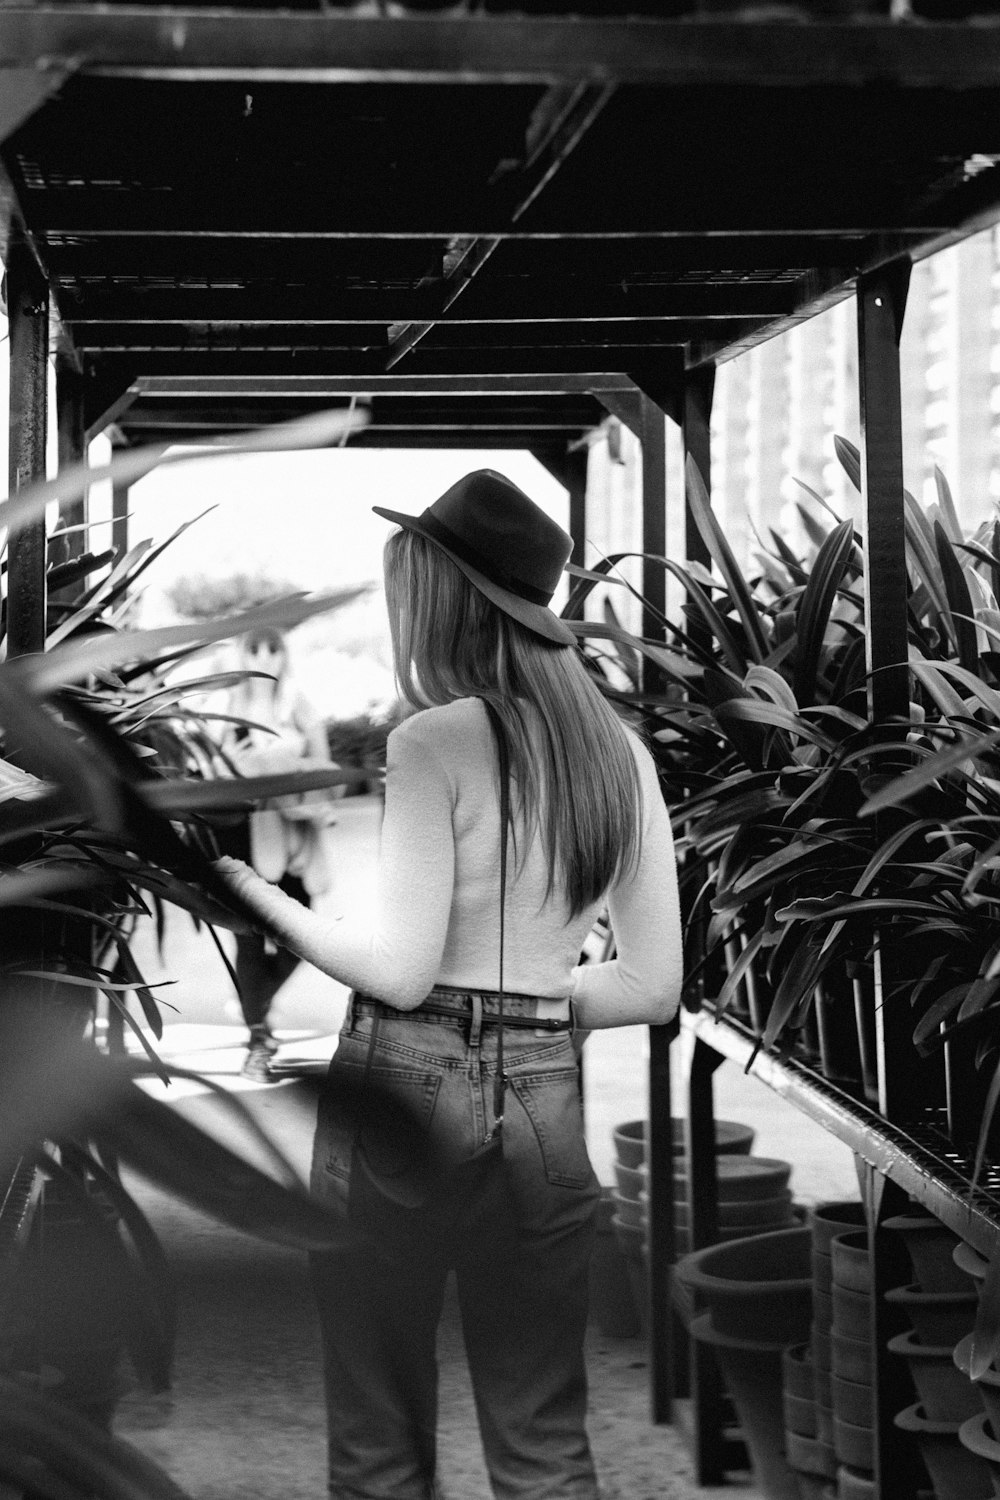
[385,84,615,369]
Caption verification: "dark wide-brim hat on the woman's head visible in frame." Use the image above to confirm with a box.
[372,470,576,647]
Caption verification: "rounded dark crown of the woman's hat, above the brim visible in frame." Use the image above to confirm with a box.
[421,470,573,605]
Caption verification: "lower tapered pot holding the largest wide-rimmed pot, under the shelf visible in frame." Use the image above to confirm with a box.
[690,1314,799,1500]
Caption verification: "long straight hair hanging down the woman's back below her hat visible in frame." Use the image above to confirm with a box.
[385,530,642,917]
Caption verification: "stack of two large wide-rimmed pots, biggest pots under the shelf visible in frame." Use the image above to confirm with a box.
[678,1227,813,1500]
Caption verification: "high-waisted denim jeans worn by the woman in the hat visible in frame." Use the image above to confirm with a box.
[305,992,600,1500]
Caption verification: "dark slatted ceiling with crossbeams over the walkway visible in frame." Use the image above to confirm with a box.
[0,0,1000,455]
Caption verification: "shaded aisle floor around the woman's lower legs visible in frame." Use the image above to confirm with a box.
[115,1181,746,1500]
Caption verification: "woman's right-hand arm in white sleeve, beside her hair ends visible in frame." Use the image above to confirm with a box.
[573,750,684,1031]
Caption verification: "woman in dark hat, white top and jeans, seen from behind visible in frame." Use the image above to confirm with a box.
[215,470,681,1500]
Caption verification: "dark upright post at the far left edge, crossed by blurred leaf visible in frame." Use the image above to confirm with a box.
[6,240,48,657]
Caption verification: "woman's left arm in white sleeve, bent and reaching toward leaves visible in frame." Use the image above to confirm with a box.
[220,717,454,1010]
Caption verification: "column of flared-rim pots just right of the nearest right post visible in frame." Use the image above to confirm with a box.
[885,1212,990,1500]
